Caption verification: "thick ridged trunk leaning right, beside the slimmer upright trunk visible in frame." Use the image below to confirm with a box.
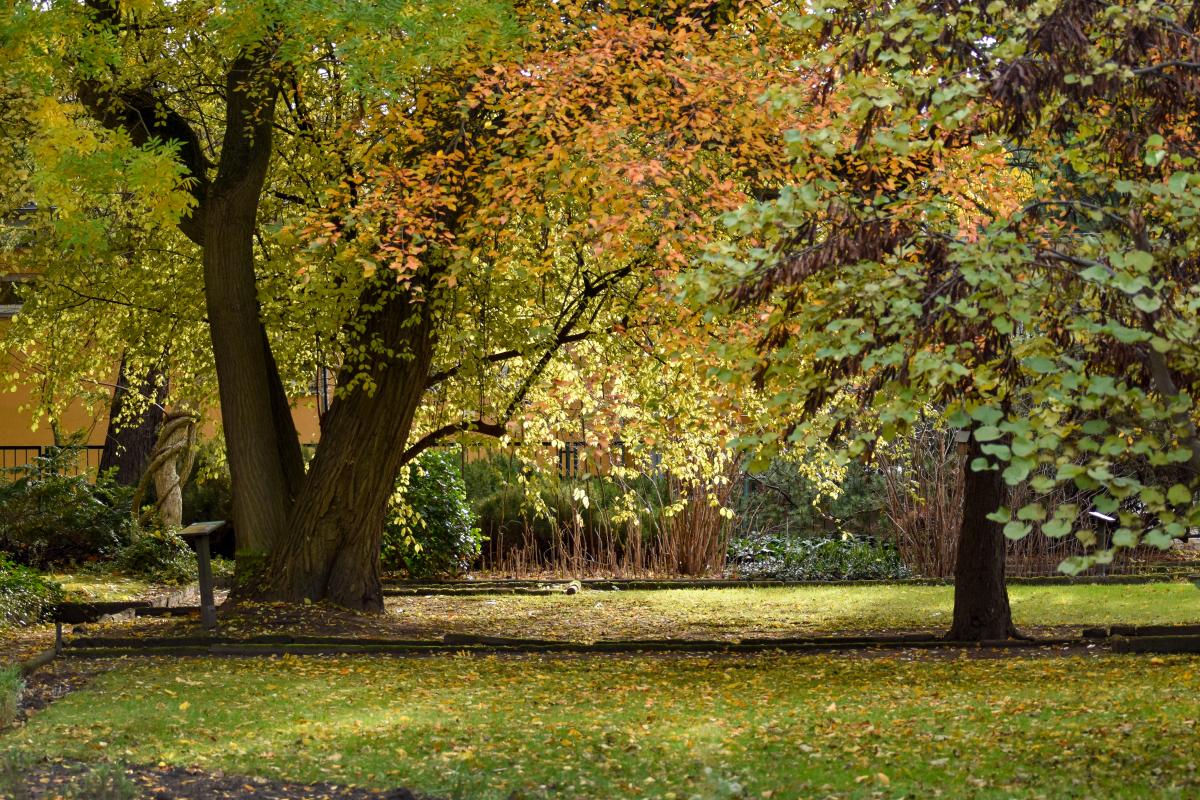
[268,290,433,610]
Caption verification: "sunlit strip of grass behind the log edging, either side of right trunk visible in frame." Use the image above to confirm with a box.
[388,583,1200,639]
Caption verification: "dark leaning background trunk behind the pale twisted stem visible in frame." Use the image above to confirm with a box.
[100,356,167,486]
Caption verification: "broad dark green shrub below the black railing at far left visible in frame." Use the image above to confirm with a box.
[0,447,133,567]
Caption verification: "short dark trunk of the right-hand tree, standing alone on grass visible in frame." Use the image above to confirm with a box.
[946,438,1016,642]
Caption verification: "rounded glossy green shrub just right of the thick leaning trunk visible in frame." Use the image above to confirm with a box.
[383,450,482,578]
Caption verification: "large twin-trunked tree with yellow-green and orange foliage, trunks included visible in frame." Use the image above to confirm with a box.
[4,0,804,607]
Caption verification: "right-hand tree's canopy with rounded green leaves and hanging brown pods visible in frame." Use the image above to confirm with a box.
[700,0,1200,571]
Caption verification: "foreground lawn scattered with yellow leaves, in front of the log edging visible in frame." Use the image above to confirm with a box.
[0,656,1200,800]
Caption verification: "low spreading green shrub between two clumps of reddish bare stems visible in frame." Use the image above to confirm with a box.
[730,536,912,581]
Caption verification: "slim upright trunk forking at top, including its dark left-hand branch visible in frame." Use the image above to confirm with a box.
[77,20,304,579]
